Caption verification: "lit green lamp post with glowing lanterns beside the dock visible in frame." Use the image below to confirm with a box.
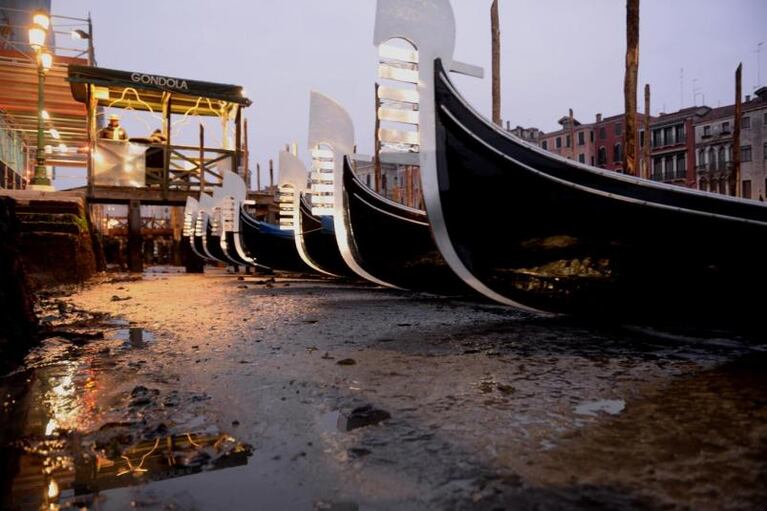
[29,11,53,190]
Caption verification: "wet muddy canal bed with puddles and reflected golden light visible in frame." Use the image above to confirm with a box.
[2,273,767,510]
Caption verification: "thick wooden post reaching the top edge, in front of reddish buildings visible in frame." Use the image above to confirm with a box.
[623,0,639,176]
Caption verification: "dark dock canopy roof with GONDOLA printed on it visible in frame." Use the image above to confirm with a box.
[68,65,251,115]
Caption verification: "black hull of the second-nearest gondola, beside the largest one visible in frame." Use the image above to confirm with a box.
[343,157,476,296]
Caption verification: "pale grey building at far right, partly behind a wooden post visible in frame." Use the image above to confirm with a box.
[695,87,767,200]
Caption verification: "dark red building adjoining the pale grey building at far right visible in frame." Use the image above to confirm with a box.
[643,106,711,188]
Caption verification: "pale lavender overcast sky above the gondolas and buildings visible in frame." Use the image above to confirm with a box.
[52,0,767,187]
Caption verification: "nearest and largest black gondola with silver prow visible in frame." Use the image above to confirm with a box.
[376,0,767,325]
